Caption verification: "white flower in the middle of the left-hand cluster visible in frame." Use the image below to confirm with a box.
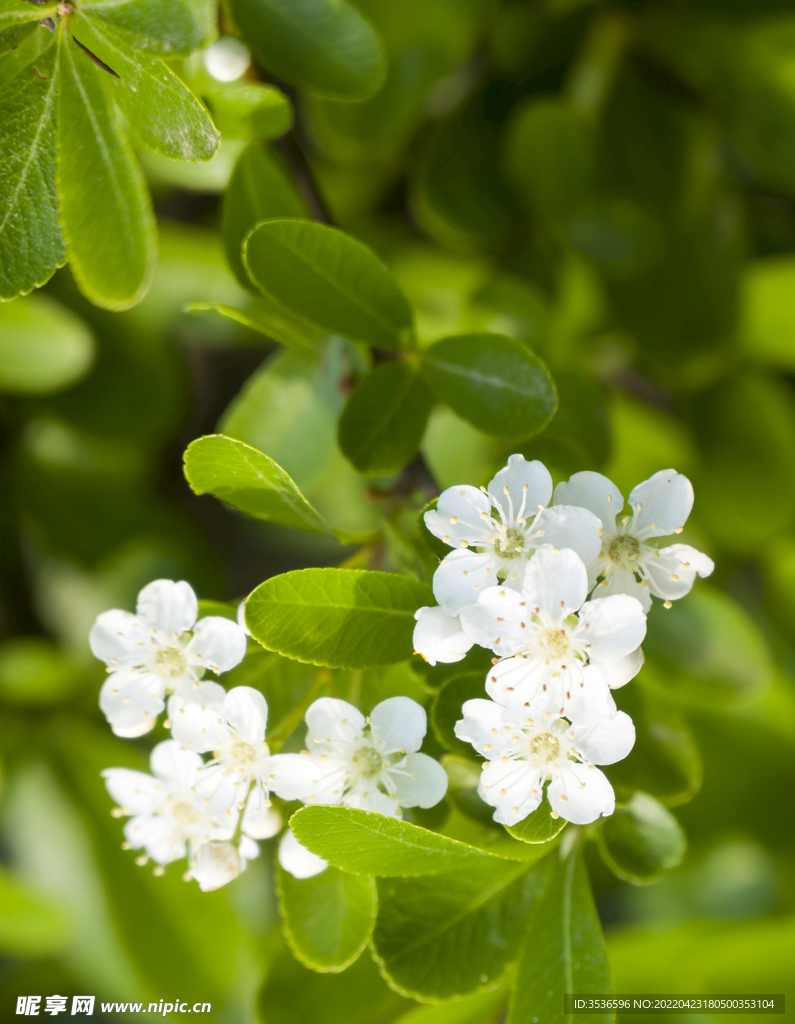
[168,684,315,839]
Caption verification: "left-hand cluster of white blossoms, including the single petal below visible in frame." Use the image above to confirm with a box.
[90,580,447,891]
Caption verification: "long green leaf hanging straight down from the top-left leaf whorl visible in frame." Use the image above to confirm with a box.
[57,29,157,309]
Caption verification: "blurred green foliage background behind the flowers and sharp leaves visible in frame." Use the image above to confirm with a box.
[0,0,795,1024]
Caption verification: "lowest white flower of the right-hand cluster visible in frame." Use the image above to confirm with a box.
[456,699,635,825]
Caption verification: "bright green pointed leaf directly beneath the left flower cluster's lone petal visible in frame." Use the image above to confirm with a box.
[290,806,499,879]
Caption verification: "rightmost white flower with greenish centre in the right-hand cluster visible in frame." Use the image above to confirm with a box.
[555,469,715,611]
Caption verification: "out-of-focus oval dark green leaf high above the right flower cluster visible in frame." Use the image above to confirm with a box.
[506,97,595,219]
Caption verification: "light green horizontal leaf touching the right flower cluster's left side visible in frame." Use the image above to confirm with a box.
[246,568,431,669]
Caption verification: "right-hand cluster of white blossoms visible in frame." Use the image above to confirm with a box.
[414,455,714,825]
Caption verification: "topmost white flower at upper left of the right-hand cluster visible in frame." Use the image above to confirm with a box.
[425,455,601,615]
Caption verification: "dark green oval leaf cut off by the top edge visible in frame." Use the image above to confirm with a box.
[226,0,386,100]
